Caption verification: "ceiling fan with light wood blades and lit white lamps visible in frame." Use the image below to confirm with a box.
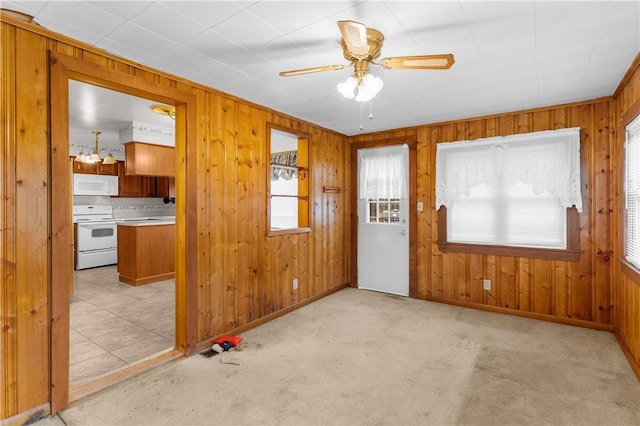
[280,21,454,102]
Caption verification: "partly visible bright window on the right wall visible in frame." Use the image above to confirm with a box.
[624,115,640,268]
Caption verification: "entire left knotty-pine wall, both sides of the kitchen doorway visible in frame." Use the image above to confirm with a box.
[0,15,350,419]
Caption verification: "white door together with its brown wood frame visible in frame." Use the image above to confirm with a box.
[350,136,417,297]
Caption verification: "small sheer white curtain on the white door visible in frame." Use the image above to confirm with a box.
[360,154,407,199]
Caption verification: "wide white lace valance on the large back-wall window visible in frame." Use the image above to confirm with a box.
[436,128,582,212]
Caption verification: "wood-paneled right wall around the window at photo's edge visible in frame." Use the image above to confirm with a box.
[611,54,640,379]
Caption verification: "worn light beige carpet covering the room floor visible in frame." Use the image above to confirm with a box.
[39,289,640,425]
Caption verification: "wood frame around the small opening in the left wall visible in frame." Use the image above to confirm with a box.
[266,123,311,237]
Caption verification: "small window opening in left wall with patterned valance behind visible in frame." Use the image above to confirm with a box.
[267,128,309,233]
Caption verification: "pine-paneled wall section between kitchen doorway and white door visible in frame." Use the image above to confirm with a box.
[198,99,348,342]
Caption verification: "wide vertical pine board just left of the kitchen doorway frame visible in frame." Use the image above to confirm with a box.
[15,30,49,411]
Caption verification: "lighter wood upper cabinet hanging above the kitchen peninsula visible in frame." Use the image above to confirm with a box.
[124,142,176,177]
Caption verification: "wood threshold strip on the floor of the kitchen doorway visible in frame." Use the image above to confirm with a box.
[69,349,184,407]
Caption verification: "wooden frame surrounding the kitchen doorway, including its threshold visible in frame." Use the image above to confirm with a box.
[50,53,197,414]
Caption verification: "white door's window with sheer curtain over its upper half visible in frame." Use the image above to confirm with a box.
[359,154,407,225]
